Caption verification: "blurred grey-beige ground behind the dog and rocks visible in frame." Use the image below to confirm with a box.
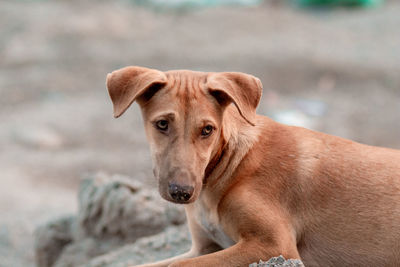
[0,0,400,266]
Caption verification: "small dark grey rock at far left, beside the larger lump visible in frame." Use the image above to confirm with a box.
[34,216,75,267]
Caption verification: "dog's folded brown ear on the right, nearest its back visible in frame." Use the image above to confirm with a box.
[207,72,262,126]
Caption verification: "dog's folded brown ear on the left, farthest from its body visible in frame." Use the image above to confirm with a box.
[106,67,167,118]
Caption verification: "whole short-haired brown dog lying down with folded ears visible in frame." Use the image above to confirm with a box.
[107,67,400,266]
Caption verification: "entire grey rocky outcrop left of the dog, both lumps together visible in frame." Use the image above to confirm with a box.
[35,173,186,267]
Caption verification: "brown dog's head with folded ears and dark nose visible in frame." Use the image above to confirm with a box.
[107,67,262,203]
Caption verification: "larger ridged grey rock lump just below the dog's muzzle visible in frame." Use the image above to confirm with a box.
[78,174,186,242]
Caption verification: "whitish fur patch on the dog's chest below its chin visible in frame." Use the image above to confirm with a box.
[195,206,235,248]
